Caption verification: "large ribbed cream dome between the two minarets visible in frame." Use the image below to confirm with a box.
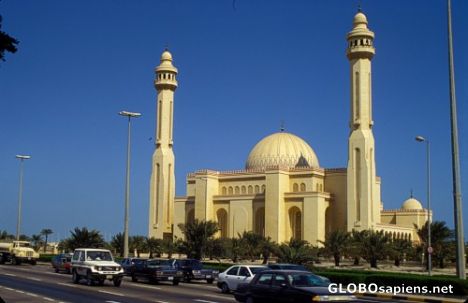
[245,132,320,170]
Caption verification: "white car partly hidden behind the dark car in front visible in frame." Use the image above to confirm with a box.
[216,264,269,293]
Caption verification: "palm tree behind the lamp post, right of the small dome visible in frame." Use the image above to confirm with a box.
[418,221,454,268]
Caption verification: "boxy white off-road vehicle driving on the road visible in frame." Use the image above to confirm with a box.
[71,248,124,287]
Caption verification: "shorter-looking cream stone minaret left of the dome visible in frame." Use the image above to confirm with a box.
[148,49,177,239]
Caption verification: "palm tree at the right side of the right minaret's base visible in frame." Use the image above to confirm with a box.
[357,230,390,268]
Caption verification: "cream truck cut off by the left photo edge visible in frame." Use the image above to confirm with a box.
[0,241,39,265]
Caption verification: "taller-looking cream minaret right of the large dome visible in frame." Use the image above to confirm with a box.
[347,11,380,231]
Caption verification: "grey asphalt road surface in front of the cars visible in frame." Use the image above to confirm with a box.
[0,264,412,303]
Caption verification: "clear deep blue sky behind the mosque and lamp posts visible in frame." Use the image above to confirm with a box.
[0,0,468,240]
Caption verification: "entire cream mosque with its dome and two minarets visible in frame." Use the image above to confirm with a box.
[148,12,432,245]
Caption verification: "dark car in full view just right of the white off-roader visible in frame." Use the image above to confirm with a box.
[131,259,183,285]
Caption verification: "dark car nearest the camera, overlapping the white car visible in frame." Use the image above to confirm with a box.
[234,270,356,303]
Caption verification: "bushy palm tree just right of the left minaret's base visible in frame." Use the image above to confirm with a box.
[179,219,219,260]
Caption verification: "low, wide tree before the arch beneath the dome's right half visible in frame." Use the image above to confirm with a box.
[276,239,318,264]
